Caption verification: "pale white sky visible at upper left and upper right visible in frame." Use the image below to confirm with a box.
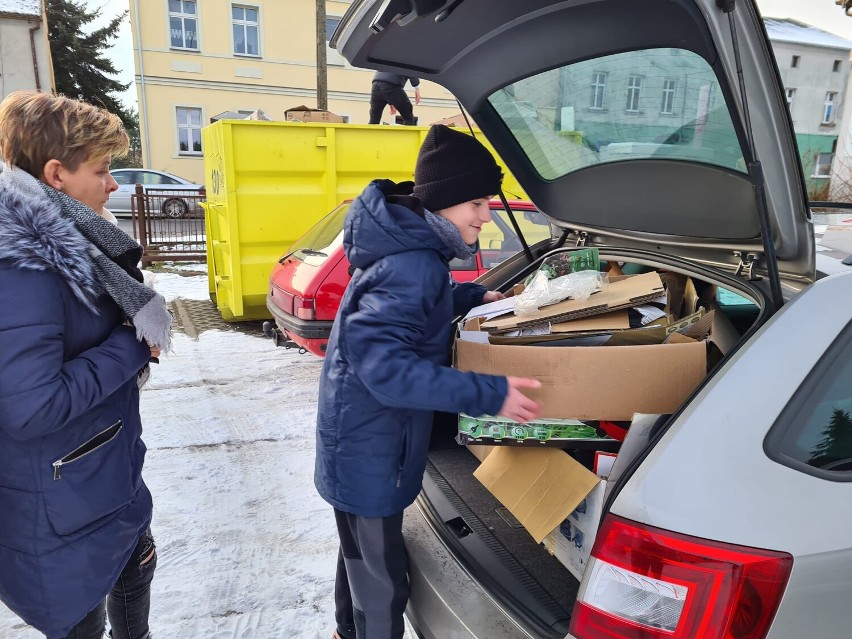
[84,0,852,112]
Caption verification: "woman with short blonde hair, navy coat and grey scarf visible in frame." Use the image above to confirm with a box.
[0,91,171,639]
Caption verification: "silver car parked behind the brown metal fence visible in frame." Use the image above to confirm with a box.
[106,168,206,218]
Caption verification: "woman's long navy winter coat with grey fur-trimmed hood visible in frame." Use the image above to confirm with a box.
[0,178,152,638]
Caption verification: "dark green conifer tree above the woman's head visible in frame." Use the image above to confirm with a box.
[46,0,133,133]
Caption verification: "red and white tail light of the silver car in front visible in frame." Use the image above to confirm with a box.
[570,515,793,639]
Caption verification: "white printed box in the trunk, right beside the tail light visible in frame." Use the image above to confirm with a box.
[542,480,606,579]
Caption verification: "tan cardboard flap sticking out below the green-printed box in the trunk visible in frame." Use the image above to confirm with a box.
[473,447,599,543]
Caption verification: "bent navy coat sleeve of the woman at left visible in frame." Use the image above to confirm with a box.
[0,271,151,440]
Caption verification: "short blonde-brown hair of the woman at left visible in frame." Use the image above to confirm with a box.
[0,91,130,178]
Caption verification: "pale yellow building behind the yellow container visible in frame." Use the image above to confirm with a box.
[127,0,458,182]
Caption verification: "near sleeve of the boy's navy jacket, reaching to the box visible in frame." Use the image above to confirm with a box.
[342,264,508,415]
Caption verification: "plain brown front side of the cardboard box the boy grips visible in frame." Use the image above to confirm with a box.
[455,340,707,422]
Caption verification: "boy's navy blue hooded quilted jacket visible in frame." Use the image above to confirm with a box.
[314,180,507,517]
